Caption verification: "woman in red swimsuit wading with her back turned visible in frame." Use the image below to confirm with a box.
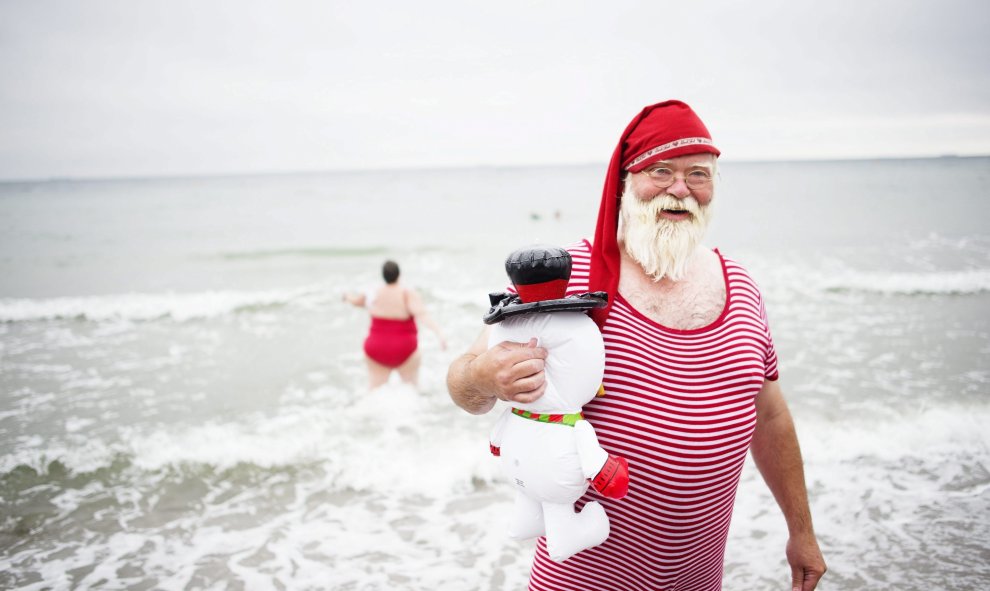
[343,261,447,388]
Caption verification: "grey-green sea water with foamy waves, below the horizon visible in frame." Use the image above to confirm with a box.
[0,158,990,591]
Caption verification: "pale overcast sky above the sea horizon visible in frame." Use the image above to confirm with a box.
[0,0,990,179]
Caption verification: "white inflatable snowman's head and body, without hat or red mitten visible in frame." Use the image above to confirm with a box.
[488,311,609,561]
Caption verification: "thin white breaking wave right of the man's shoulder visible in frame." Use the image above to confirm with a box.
[821,269,990,295]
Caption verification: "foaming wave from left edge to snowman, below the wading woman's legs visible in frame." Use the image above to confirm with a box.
[0,384,499,496]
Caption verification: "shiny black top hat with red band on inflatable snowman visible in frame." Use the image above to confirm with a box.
[484,246,608,324]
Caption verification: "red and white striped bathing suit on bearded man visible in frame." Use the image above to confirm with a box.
[529,241,777,591]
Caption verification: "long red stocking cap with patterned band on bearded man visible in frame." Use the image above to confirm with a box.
[588,101,720,328]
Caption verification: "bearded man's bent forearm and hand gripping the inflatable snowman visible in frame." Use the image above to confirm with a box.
[447,327,547,415]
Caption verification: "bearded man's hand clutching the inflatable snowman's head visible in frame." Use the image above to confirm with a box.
[470,339,547,404]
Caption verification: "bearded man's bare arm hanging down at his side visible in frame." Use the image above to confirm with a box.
[751,380,826,591]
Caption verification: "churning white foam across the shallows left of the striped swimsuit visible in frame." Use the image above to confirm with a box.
[0,384,532,591]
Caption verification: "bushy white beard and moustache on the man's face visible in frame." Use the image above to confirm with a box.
[618,178,711,281]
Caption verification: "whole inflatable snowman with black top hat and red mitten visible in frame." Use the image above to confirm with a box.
[484,247,629,562]
